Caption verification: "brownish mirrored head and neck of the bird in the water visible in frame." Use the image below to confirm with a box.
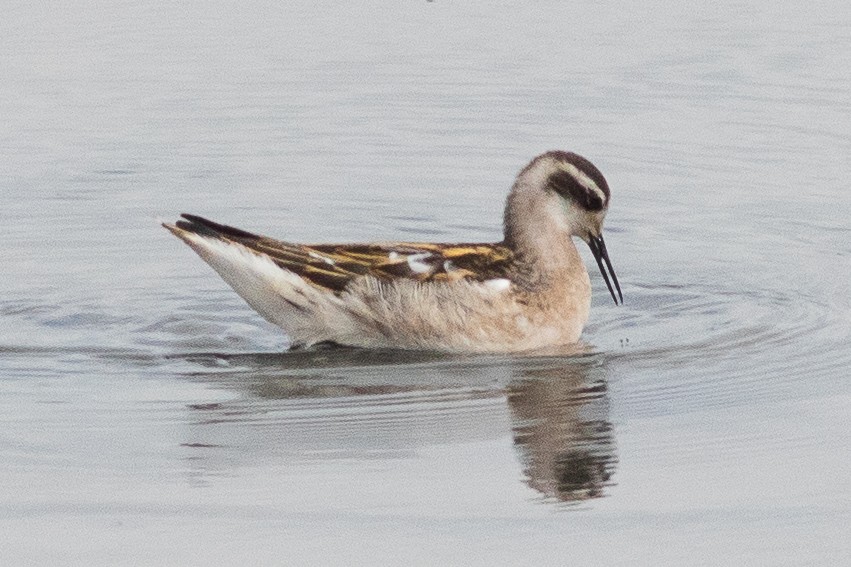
[507,361,617,502]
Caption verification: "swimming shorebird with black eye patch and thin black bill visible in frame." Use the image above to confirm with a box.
[163,150,623,354]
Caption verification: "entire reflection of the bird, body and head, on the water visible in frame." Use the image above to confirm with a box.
[183,349,617,502]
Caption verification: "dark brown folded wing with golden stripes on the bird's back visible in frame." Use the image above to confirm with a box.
[170,214,513,293]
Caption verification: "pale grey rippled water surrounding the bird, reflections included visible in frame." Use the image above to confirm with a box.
[0,0,851,565]
